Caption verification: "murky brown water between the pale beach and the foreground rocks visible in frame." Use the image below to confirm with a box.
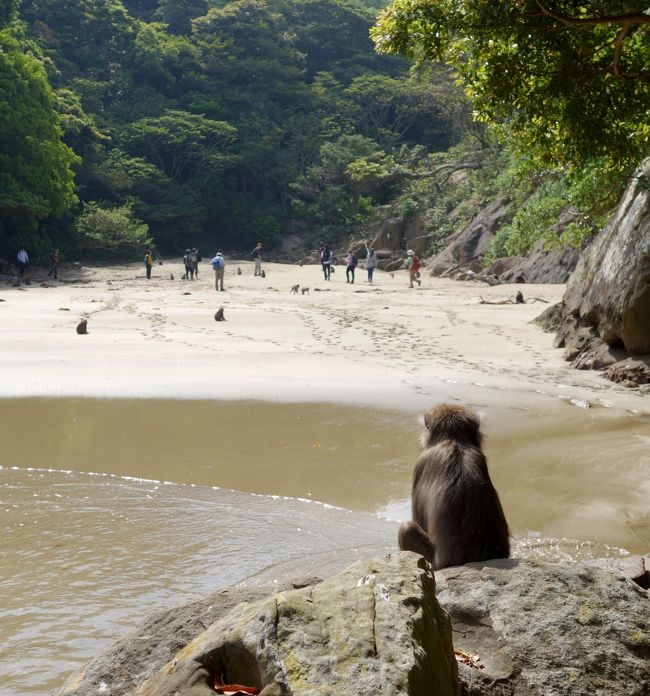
[0,399,650,696]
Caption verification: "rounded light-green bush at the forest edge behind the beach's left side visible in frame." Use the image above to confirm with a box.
[75,201,153,258]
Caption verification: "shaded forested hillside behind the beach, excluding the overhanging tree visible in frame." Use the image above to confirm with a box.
[0,0,469,258]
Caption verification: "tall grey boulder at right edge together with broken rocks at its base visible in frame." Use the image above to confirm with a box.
[555,159,650,384]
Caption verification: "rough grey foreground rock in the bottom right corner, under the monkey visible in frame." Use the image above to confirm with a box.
[436,560,650,696]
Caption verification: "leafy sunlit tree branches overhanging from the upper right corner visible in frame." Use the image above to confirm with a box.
[372,0,650,169]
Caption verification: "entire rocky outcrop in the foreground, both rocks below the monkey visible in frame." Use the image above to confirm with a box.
[57,553,650,696]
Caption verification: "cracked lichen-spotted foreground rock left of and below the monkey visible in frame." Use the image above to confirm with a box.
[59,553,458,696]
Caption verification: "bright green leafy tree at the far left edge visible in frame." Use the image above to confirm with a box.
[0,29,79,241]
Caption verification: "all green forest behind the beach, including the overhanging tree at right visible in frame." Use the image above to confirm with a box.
[0,0,650,266]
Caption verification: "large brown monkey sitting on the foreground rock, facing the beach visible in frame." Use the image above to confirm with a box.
[398,404,510,570]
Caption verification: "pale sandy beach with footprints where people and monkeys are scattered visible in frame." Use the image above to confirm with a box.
[0,260,648,413]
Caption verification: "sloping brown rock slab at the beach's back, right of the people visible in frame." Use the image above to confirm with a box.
[427,198,511,275]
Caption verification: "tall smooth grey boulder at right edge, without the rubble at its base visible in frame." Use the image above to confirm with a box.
[558,158,650,355]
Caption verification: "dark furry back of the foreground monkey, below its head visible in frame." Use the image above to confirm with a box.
[412,439,510,568]
